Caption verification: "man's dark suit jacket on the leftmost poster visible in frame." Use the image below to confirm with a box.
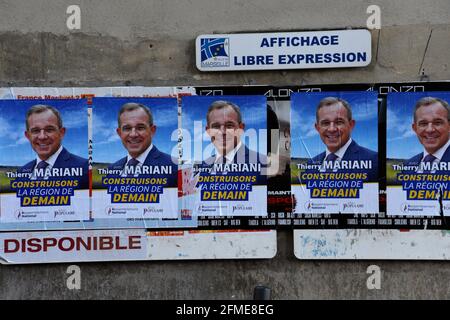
[18,148,89,189]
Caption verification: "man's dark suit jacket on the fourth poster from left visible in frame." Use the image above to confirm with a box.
[308,140,378,181]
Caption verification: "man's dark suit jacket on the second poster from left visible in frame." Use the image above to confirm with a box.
[108,145,178,187]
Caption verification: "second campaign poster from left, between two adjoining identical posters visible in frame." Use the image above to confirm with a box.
[92,98,178,221]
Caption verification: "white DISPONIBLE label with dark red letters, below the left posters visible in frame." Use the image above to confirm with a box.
[0,229,147,263]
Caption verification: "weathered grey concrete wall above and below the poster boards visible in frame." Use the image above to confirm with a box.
[0,0,450,299]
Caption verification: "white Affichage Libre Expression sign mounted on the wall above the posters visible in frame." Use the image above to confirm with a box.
[195,29,372,71]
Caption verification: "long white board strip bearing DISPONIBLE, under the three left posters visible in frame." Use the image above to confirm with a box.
[0,229,277,264]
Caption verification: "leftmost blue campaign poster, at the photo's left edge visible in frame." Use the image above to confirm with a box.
[0,99,89,223]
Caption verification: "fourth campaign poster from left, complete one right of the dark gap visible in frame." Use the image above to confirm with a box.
[291,91,379,214]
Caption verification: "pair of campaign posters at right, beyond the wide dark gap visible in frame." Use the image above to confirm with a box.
[291,91,450,217]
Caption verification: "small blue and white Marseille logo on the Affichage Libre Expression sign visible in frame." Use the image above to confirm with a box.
[200,38,230,68]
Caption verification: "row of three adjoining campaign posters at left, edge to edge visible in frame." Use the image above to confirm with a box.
[0,96,267,223]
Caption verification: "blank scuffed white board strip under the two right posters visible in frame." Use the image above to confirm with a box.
[294,229,450,260]
